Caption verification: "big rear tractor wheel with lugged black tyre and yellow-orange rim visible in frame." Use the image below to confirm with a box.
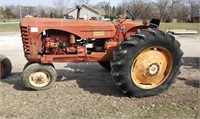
[111,29,183,97]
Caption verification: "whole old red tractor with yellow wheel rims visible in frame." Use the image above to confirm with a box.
[20,10,183,97]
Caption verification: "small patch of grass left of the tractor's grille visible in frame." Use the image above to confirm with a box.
[0,22,20,32]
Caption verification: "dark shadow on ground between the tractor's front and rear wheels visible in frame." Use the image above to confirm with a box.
[57,63,124,97]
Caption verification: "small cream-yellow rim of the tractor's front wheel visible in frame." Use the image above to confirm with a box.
[29,71,51,88]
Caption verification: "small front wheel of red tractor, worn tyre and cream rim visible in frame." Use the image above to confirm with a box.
[22,63,57,90]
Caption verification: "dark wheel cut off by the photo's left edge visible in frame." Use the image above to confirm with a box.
[0,54,12,79]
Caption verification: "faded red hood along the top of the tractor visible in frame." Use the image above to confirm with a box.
[20,17,116,38]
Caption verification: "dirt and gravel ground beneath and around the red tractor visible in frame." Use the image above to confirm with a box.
[0,33,200,119]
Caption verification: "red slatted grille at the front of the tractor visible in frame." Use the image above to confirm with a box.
[21,27,30,55]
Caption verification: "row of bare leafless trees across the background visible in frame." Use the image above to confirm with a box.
[0,0,200,22]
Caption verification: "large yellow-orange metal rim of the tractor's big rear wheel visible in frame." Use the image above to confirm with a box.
[131,46,173,89]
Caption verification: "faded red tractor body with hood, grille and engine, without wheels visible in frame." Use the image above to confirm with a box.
[20,18,148,63]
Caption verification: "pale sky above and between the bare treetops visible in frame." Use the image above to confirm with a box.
[0,0,155,7]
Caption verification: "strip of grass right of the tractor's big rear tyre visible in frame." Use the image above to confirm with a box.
[160,23,200,34]
